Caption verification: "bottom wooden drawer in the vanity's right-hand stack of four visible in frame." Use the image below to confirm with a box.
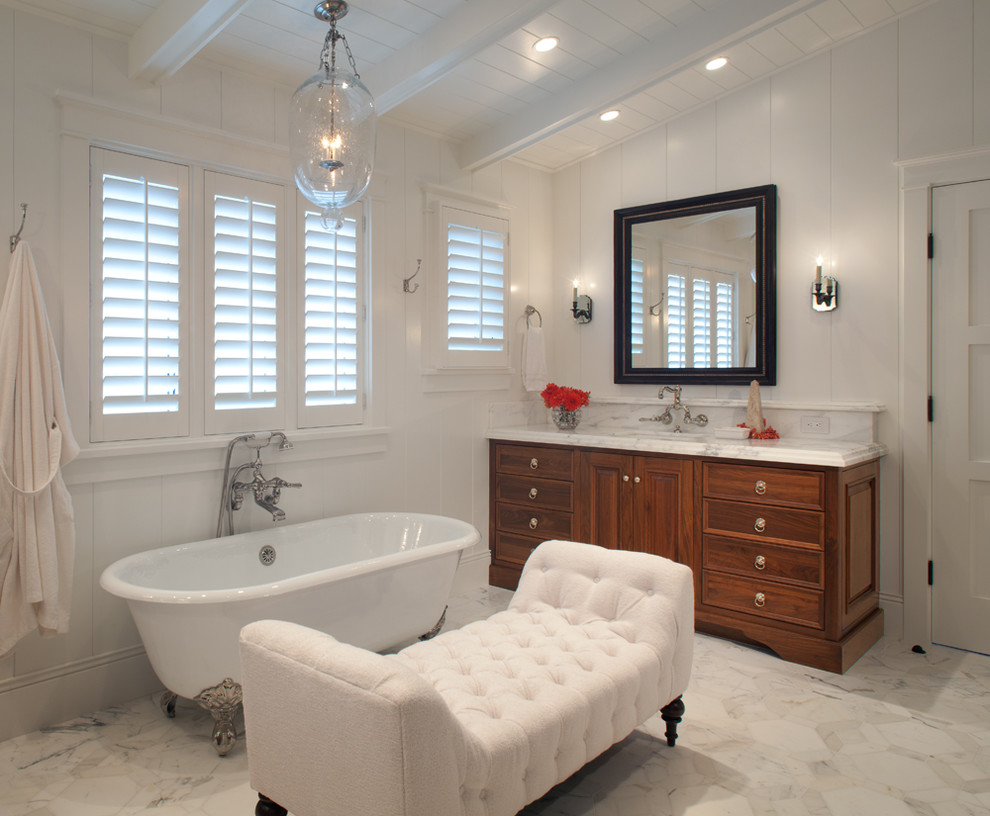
[701,571,825,629]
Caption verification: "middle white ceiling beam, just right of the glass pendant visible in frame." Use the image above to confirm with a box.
[361,0,558,115]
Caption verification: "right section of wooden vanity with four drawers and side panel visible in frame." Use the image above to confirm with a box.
[694,460,883,672]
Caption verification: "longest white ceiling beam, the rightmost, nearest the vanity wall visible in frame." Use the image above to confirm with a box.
[459,0,822,170]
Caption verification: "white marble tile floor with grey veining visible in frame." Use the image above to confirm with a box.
[0,587,990,816]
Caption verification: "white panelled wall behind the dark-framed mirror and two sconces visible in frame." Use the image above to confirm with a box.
[551,0,990,644]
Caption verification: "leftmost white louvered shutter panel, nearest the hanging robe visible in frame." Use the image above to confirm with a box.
[91,148,189,441]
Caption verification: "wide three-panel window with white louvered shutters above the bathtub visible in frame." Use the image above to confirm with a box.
[90,147,365,442]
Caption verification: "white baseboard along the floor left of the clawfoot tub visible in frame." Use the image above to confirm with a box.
[0,647,162,742]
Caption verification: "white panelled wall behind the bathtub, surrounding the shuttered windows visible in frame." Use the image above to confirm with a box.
[0,6,552,740]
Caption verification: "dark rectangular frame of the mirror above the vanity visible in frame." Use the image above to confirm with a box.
[615,184,777,385]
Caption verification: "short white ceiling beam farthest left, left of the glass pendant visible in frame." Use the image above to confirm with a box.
[127,0,251,82]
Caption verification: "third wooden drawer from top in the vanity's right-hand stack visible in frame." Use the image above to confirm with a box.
[702,536,824,589]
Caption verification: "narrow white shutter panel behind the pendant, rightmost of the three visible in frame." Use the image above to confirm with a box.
[299,207,363,427]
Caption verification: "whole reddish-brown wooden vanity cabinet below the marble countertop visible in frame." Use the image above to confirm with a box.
[489,440,883,672]
